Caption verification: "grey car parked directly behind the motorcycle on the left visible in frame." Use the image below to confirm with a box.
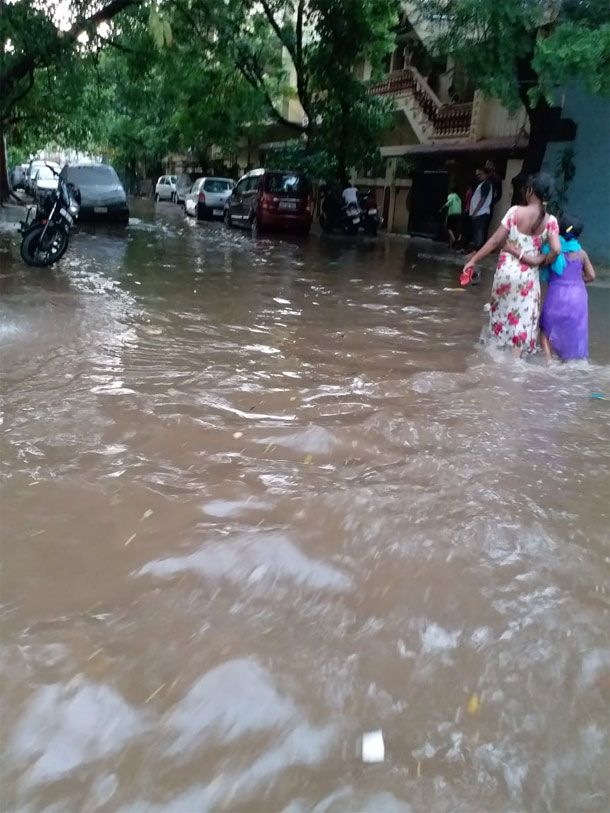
[61,164,129,223]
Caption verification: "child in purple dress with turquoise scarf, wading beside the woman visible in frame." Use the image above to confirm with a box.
[540,215,595,361]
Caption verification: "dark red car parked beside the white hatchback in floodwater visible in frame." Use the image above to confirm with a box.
[224,169,313,236]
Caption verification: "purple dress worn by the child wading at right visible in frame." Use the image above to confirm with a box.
[540,254,589,361]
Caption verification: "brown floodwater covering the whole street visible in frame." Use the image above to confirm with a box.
[0,198,610,813]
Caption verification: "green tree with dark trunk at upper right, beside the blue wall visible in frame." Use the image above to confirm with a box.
[409,0,610,173]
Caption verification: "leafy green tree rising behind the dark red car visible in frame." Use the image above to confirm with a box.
[176,0,398,179]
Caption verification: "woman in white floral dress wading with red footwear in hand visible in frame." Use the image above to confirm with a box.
[463,173,561,356]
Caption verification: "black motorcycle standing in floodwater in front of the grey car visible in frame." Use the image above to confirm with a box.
[19,167,80,268]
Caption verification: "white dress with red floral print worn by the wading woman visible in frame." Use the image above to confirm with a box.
[489,206,559,353]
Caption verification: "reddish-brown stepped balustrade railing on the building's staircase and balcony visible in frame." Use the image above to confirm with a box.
[368,67,472,138]
